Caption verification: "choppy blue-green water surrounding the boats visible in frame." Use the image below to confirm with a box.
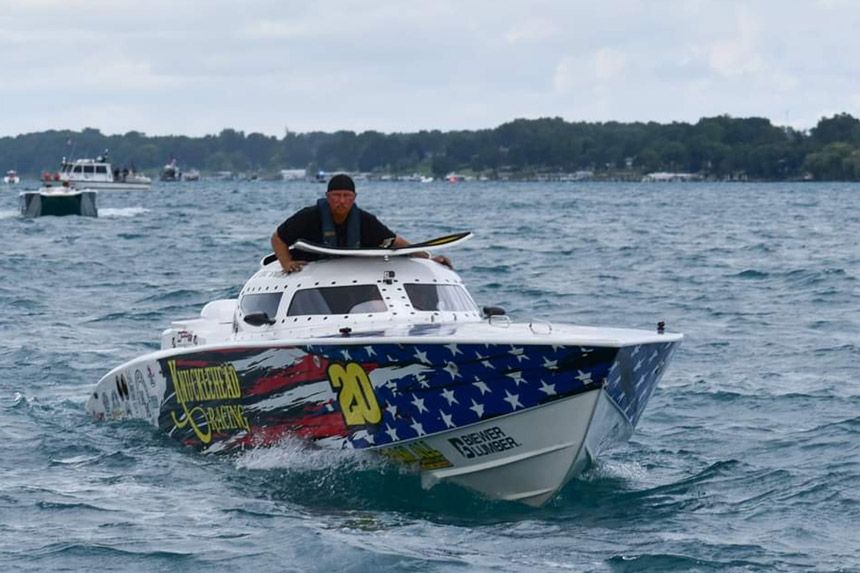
[0,182,860,572]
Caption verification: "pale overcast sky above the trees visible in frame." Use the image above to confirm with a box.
[0,0,860,137]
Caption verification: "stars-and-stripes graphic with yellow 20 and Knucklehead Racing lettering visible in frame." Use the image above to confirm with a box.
[159,339,674,451]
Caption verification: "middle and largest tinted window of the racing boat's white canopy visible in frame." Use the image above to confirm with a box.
[287,285,388,316]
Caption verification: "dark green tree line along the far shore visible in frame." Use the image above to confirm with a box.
[0,113,860,181]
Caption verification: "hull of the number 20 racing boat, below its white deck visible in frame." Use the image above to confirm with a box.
[86,325,680,506]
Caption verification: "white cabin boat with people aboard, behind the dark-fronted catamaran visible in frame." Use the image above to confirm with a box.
[42,150,152,191]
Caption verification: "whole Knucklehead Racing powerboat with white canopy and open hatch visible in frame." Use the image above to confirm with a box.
[86,233,682,506]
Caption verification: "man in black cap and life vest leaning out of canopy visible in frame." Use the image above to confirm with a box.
[272,174,451,273]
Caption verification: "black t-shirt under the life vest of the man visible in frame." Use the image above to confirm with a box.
[278,205,396,261]
